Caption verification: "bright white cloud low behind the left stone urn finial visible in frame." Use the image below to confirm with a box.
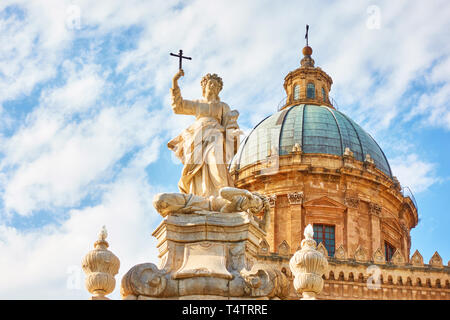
[0,175,161,299]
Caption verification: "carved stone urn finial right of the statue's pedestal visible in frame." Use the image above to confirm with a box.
[289,224,328,300]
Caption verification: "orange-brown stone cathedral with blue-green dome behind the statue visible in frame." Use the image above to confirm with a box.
[231,46,450,299]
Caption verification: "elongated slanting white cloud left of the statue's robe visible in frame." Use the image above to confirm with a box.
[3,106,163,215]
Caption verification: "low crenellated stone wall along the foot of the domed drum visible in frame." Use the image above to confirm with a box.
[258,253,450,300]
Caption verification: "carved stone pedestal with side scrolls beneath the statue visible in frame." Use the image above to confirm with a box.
[121,212,289,299]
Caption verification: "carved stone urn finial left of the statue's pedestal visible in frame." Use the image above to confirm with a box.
[82,226,120,300]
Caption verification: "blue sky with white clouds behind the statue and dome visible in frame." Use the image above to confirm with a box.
[0,0,450,299]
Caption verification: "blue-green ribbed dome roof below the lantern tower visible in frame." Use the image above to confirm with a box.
[231,104,392,178]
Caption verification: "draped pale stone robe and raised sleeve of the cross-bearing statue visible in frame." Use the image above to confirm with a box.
[167,88,239,197]
